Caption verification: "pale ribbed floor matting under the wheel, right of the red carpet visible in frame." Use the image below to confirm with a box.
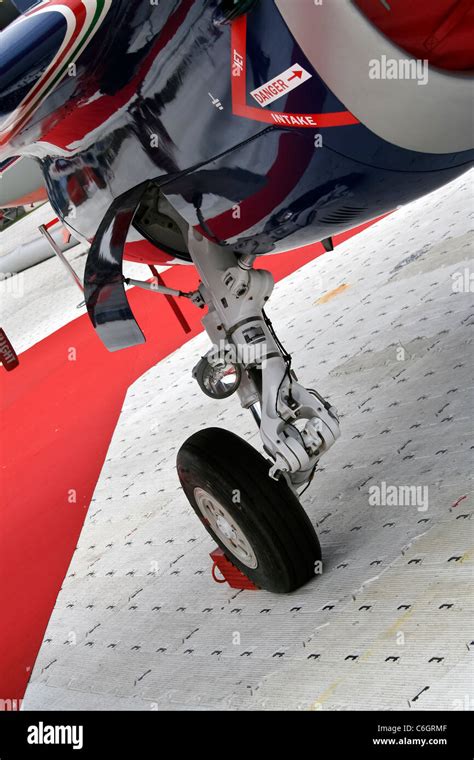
[20,175,474,710]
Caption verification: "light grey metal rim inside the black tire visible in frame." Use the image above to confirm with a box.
[194,488,258,570]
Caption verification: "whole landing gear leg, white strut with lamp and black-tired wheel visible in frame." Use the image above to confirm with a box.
[177,229,339,593]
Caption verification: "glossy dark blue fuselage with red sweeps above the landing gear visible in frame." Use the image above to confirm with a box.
[0,0,474,254]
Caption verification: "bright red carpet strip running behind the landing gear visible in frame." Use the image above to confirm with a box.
[0,220,386,700]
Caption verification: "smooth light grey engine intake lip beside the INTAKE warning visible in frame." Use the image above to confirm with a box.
[275,0,474,154]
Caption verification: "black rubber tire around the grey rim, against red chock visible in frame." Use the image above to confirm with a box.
[177,428,321,594]
